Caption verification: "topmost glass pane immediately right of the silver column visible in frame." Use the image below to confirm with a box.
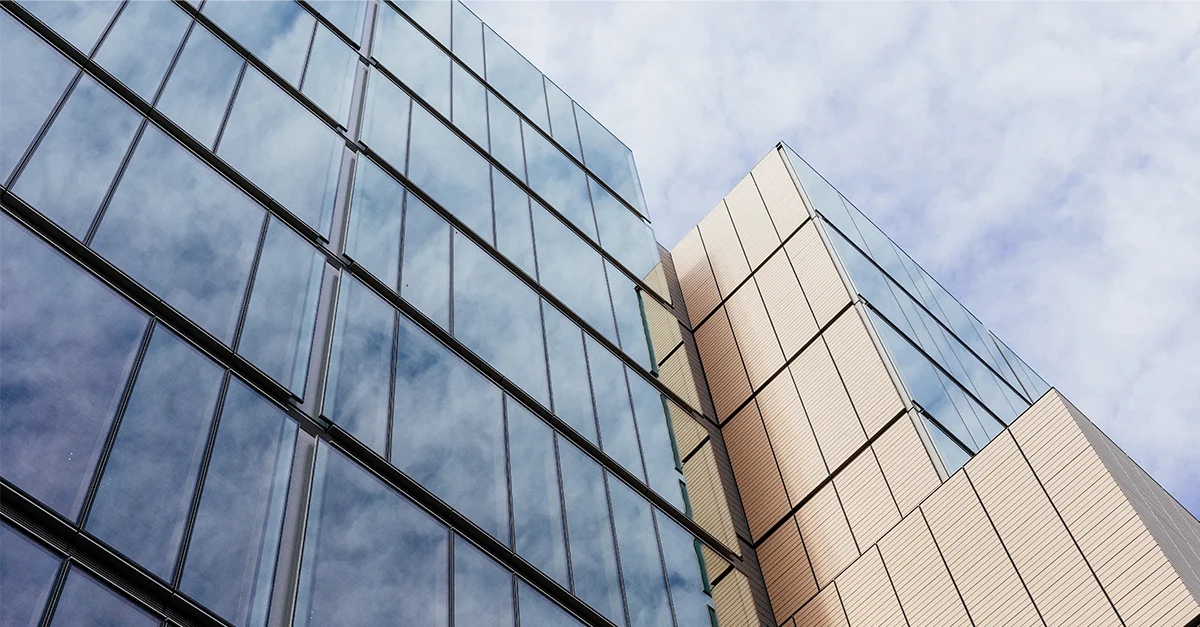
[373,2,450,118]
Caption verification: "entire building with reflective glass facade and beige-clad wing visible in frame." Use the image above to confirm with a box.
[0,0,1200,627]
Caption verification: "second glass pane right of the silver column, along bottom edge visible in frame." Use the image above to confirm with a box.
[454,537,512,627]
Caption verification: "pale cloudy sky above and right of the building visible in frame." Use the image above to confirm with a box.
[470,1,1200,514]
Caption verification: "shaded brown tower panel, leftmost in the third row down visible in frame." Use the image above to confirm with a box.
[721,401,791,541]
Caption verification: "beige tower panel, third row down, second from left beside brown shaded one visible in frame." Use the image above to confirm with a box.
[755,370,829,507]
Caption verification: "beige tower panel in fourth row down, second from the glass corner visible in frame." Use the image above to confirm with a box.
[833,448,900,547]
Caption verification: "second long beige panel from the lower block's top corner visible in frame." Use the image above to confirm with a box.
[966,431,1121,626]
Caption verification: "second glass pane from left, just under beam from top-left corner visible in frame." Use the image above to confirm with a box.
[13,76,142,239]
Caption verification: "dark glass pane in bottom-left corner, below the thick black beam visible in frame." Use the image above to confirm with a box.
[0,523,62,627]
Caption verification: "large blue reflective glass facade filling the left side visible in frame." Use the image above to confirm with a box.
[0,0,742,627]
